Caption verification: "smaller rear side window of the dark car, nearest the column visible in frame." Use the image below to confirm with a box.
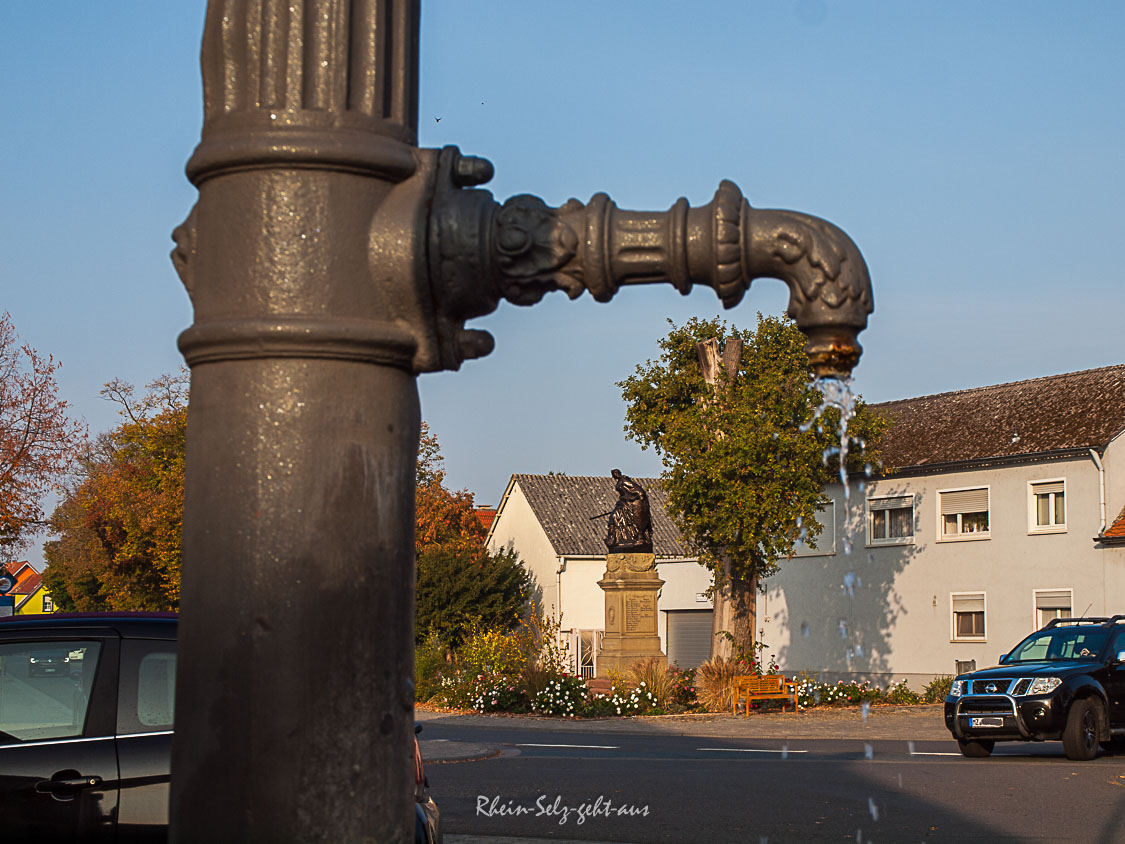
[117,639,176,735]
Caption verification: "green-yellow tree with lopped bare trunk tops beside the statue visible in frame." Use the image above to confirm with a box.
[618,314,885,655]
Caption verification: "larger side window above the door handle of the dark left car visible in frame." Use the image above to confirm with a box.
[0,641,101,742]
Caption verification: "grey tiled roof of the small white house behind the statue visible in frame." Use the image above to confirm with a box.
[512,475,694,557]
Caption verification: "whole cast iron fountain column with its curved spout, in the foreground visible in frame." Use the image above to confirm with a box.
[171,0,872,843]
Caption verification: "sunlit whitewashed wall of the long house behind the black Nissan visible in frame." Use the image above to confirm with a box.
[758,459,1125,688]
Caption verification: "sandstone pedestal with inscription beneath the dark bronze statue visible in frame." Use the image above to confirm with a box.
[597,554,668,677]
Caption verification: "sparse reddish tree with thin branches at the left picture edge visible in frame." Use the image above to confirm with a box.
[0,313,86,550]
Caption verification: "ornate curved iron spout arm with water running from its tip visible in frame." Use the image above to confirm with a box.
[430,159,874,377]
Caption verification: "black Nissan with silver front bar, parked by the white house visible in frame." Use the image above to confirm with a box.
[945,616,1125,760]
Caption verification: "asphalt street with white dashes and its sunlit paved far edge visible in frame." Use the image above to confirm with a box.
[420,709,1125,844]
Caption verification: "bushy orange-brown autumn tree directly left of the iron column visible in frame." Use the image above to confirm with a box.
[44,372,187,610]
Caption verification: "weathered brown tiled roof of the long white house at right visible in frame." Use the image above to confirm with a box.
[872,365,1125,469]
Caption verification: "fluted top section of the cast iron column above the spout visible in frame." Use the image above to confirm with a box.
[188,0,419,185]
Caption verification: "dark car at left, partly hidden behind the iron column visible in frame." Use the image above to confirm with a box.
[0,613,440,844]
